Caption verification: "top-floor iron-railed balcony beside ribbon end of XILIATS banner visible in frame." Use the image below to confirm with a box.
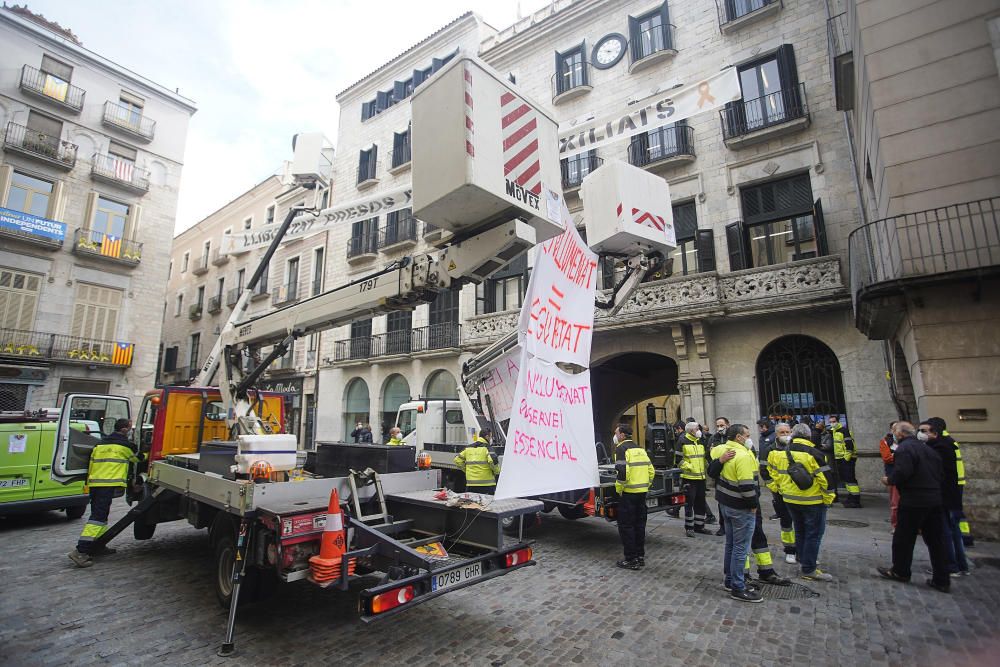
[719,83,809,148]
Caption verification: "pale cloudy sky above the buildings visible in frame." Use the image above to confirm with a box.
[19,0,548,232]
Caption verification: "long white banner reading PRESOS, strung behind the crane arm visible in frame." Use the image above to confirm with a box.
[221,185,413,254]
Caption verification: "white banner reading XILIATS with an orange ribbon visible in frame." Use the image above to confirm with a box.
[559,67,743,158]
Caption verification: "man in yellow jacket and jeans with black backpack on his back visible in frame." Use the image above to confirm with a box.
[768,424,834,582]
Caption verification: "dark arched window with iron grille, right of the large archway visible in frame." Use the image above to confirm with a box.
[757,335,846,420]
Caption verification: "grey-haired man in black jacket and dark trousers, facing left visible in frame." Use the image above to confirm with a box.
[878,421,951,593]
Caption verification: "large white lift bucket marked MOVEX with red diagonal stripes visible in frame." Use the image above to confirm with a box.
[410,56,563,241]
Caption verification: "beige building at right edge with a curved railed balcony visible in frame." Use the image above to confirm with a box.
[829,0,1000,538]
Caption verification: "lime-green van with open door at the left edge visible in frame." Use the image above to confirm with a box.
[0,394,128,519]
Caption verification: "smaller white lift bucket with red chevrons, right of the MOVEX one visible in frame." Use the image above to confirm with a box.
[580,160,677,255]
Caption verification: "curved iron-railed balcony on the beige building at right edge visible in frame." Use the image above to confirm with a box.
[847,197,1000,340]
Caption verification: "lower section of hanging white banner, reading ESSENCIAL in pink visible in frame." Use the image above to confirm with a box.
[495,355,600,498]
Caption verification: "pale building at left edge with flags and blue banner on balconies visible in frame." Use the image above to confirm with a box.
[0,8,195,410]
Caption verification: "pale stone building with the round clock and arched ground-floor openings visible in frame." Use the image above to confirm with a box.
[319,0,896,504]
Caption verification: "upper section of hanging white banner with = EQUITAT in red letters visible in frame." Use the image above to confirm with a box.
[517,202,597,368]
